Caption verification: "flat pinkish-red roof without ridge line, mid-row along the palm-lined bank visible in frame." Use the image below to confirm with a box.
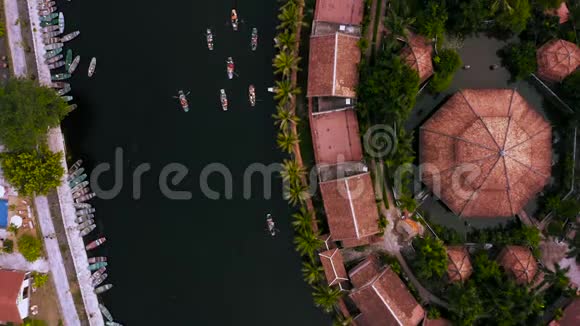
[310,108,363,164]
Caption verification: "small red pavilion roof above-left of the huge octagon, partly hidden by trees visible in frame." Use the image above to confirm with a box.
[401,35,433,83]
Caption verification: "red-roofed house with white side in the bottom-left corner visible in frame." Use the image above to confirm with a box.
[0,269,30,324]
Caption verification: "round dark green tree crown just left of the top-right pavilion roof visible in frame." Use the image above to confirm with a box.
[500,42,538,80]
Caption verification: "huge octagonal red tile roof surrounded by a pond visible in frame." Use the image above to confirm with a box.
[420,89,552,217]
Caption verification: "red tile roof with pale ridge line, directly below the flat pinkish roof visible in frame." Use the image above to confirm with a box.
[320,172,379,241]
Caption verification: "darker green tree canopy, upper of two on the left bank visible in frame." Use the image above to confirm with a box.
[0,79,68,151]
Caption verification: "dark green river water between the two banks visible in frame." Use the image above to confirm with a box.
[59,0,329,325]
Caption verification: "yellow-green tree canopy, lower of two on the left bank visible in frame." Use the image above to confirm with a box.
[0,149,64,196]
